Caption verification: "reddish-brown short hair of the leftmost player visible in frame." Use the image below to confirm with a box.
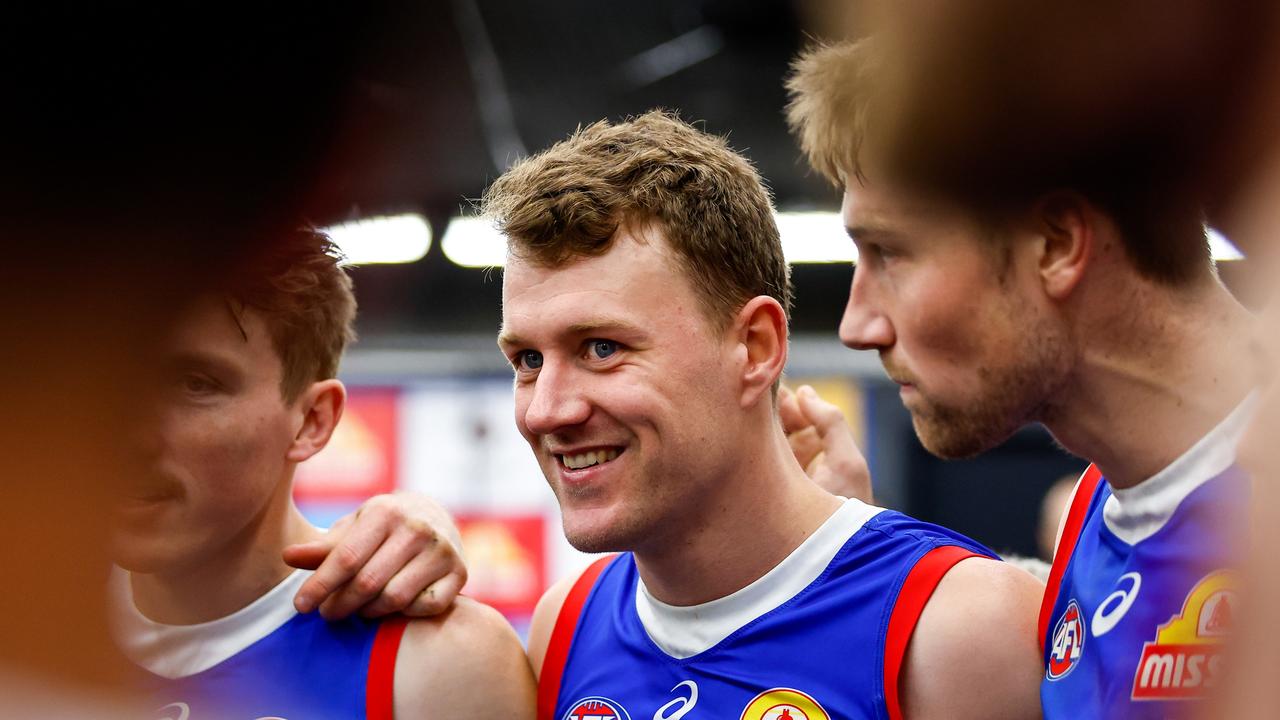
[224,228,356,402]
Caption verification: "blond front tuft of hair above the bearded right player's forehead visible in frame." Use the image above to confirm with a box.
[787,38,881,188]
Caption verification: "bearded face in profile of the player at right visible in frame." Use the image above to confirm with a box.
[840,183,1069,457]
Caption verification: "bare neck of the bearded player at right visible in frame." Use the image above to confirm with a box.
[1044,274,1253,488]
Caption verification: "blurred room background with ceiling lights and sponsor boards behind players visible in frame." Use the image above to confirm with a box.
[272,0,1240,629]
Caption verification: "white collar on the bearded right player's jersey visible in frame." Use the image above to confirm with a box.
[1102,391,1257,544]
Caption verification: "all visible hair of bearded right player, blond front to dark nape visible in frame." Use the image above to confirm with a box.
[787,38,1212,286]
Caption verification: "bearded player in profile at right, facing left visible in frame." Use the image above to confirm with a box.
[790,40,1253,717]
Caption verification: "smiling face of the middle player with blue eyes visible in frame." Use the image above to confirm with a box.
[499,228,742,552]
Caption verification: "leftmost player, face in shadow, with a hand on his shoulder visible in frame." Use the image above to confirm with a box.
[104,231,534,719]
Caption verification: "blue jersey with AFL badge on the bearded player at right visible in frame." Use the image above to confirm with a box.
[1039,401,1252,720]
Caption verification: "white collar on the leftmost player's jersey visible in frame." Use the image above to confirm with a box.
[109,566,311,679]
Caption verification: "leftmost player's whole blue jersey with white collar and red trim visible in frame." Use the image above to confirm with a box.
[113,570,404,720]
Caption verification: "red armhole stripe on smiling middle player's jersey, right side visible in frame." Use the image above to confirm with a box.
[884,544,983,720]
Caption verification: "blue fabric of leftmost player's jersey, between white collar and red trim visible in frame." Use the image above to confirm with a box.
[143,614,399,720]
